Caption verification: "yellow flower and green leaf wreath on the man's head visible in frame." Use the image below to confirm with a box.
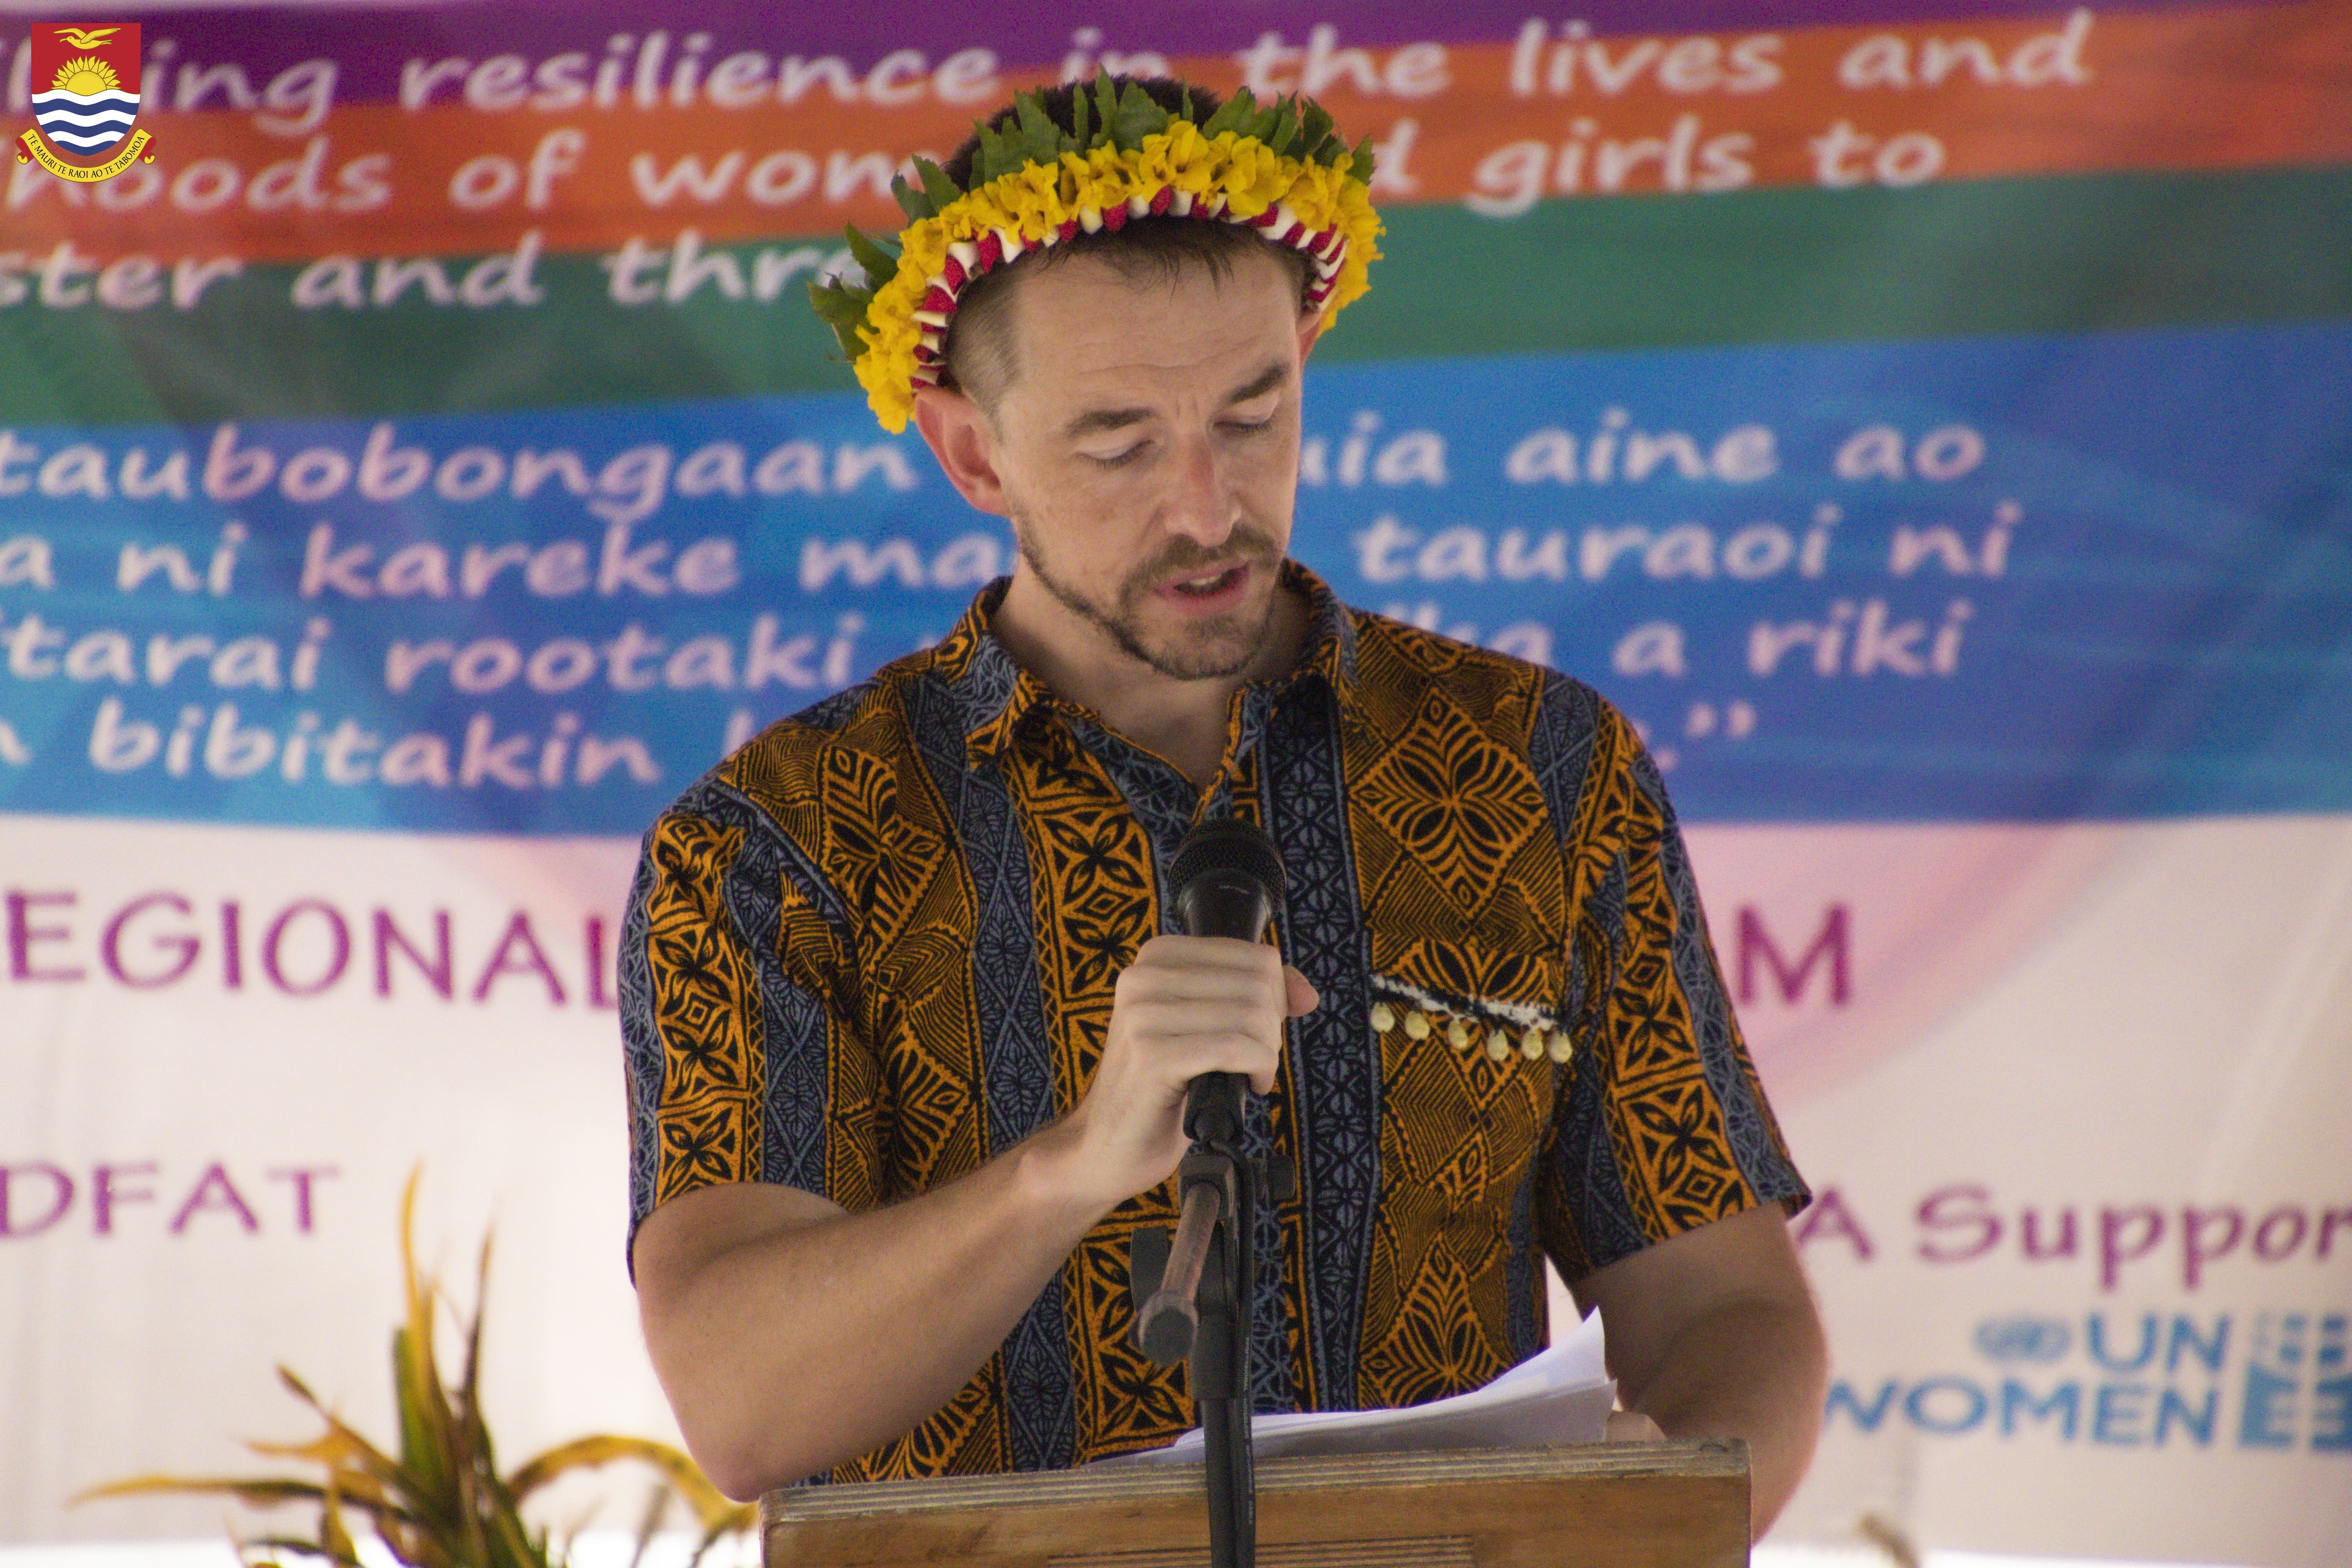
[809,78,1381,432]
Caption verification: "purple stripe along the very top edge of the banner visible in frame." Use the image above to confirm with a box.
[0,0,2288,111]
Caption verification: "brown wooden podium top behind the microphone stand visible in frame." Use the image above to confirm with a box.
[760,1441,1748,1568]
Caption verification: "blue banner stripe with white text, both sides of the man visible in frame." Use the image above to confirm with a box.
[0,322,2352,835]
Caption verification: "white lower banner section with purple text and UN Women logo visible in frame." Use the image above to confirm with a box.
[0,816,2352,1568]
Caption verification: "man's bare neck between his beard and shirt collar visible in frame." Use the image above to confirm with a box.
[990,573,1310,788]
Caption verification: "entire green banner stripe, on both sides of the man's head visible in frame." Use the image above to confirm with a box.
[0,167,2352,425]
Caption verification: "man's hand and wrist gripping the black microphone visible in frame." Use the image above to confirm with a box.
[1051,936,1317,1208]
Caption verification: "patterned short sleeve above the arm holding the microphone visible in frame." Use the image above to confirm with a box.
[619,783,877,1236]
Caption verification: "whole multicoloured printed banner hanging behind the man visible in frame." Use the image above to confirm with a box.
[0,0,2352,1568]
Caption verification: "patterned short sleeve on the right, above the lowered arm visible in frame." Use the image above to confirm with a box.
[1536,693,1811,1279]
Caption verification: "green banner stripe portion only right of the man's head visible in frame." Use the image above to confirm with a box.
[1329,167,2352,360]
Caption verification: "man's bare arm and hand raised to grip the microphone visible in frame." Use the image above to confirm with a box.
[633,936,1315,1497]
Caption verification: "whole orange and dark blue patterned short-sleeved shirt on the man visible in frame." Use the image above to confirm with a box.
[621,564,1806,1481]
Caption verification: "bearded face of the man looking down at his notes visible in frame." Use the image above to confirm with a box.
[964,252,1312,679]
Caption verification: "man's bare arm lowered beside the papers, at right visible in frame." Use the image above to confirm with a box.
[1569,1203,1830,1537]
